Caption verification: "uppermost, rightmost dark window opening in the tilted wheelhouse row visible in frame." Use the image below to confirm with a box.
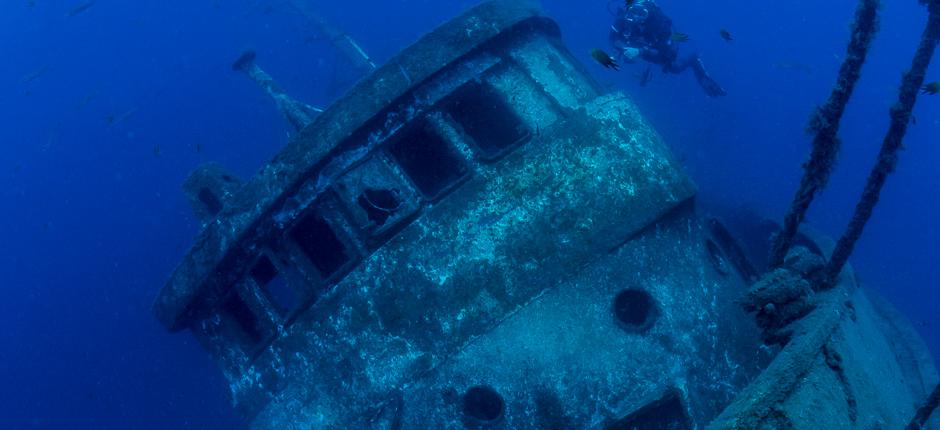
[445,81,531,158]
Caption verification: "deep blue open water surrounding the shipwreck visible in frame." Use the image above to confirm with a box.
[0,0,940,429]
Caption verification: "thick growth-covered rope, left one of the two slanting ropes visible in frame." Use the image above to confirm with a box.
[769,0,880,268]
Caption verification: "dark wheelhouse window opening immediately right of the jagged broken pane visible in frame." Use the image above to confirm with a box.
[388,124,467,199]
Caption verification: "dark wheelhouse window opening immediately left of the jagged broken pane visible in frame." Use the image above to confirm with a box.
[290,213,349,277]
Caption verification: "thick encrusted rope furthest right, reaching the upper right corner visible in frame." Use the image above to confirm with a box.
[826,4,940,284]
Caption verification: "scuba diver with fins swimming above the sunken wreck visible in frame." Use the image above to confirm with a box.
[610,0,726,97]
